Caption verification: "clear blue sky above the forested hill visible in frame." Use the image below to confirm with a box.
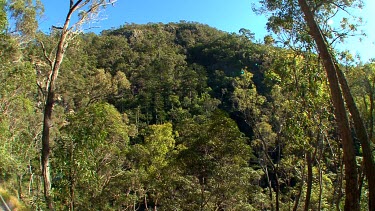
[41,0,375,61]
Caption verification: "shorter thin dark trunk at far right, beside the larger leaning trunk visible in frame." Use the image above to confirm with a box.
[336,67,375,210]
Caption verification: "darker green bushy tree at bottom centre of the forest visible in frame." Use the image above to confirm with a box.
[177,110,256,210]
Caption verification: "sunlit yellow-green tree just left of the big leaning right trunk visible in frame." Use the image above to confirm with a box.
[262,49,339,210]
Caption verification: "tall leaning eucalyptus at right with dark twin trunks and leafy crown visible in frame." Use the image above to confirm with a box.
[258,0,375,210]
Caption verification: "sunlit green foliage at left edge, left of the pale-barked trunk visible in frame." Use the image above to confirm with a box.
[0,33,40,206]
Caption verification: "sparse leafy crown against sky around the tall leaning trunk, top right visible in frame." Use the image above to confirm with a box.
[254,0,363,50]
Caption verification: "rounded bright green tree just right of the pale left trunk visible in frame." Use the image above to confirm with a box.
[52,103,129,210]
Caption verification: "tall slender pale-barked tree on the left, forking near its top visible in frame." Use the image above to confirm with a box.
[40,0,116,210]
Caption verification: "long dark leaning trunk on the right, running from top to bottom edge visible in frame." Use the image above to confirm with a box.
[298,0,360,211]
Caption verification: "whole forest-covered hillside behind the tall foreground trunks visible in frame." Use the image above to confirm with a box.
[0,22,375,210]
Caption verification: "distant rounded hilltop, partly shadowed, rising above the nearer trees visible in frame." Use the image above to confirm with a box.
[94,23,267,124]
